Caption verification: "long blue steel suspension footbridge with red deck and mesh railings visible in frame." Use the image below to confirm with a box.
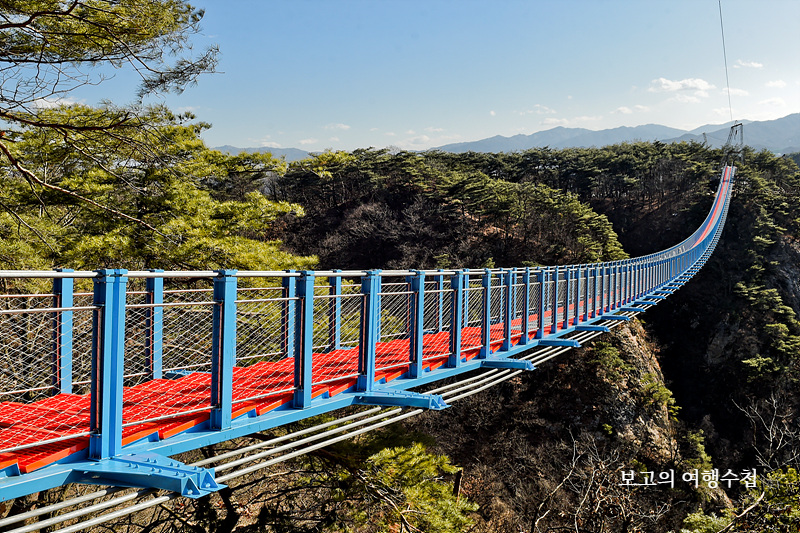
[0,166,735,500]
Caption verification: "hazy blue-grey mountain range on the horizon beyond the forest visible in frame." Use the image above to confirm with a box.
[216,113,800,161]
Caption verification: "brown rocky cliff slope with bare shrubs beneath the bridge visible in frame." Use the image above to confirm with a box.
[410,320,724,532]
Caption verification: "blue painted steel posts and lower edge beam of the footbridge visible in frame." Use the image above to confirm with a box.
[0,167,733,500]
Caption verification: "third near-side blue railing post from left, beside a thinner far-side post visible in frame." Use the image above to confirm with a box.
[294,270,316,409]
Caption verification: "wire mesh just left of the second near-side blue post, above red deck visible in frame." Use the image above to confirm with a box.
[162,289,216,373]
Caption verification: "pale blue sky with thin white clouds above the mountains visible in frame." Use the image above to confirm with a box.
[73,0,800,150]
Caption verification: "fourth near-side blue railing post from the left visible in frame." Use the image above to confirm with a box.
[357,270,381,391]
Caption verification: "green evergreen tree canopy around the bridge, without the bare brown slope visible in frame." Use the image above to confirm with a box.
[0,0,800,533]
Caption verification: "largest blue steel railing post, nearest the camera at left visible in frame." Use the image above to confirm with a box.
[89,269,128,460]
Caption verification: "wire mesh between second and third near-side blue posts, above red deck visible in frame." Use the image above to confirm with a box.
[236,287,288,366]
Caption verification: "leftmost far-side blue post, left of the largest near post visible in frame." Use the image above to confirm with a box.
[53,268,74,394]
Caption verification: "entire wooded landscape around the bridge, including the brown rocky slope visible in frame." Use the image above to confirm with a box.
[0,0,800,533]
